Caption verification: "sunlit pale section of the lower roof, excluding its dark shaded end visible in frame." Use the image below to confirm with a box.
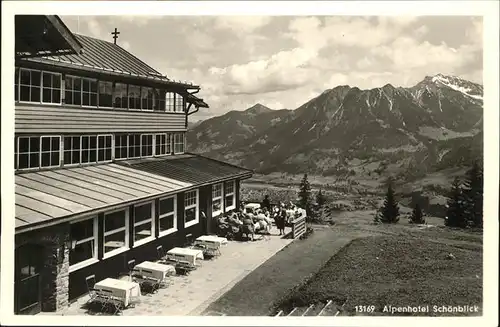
[15,164,192,230]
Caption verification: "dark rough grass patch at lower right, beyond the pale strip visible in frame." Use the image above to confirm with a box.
[285,235,482,315]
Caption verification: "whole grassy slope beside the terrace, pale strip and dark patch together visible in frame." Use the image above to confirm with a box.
[206,211,482,315]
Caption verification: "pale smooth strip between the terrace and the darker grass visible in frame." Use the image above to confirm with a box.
[202,227,354,316]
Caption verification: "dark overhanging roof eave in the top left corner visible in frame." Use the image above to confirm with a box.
[15,15,82,58]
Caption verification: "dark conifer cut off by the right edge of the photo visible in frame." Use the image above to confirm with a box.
[464,161,483,228]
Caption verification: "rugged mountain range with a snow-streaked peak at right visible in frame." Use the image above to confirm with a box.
[187,74,483,180]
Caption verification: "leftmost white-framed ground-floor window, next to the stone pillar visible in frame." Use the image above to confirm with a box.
[69,217,97,269]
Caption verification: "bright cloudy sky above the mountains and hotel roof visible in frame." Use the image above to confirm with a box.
[61,16,483,119]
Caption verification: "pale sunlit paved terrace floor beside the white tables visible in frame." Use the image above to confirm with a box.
[45,229,292,316]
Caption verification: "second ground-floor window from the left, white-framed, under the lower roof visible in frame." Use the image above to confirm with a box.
[104,209,129,256]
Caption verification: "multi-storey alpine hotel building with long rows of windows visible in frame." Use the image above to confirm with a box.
[14,15,252,314]
